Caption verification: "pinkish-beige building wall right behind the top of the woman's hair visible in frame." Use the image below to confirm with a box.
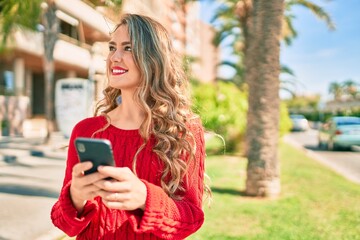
[123,0,219,82]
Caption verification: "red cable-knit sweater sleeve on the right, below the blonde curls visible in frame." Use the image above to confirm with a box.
[129,119,205,239]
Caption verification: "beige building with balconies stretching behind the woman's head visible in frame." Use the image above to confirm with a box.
[0,0,218,135]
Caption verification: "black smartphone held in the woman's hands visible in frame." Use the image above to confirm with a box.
[75,138,114,174]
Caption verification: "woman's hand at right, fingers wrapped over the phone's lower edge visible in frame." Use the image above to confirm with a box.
[94,166,147,211]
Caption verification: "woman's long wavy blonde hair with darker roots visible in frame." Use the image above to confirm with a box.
[95,14,202,198]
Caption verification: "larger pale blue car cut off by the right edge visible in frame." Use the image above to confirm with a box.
[318,116,360,150]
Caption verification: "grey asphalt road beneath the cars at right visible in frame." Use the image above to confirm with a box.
[285,129,360,184]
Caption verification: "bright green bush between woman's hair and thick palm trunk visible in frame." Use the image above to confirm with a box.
[192,82,248,152]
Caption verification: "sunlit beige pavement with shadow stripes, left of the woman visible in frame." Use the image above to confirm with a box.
[0,142,65,240]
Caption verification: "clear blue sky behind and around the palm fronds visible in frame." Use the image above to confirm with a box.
[200,0,360,101]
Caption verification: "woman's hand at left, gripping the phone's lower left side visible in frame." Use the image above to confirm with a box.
[70,162,105,214]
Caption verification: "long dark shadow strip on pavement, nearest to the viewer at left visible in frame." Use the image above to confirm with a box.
[0,183,59,199]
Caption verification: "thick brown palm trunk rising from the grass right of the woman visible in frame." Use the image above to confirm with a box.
[245,0,284,197]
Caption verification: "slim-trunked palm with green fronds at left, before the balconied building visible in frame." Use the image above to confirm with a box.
[1,0,59,141]
